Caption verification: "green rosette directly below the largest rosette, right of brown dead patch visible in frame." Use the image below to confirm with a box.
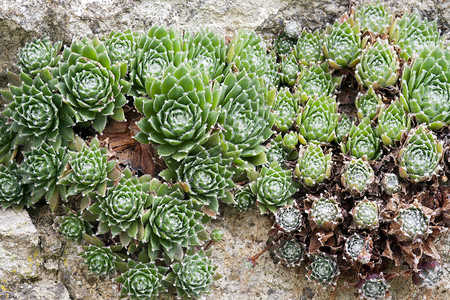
[164,146,234,213]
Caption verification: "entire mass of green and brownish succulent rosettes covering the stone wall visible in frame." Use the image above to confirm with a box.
[0,4,450,299]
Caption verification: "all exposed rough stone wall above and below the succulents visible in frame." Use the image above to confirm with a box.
[0,0,450,300]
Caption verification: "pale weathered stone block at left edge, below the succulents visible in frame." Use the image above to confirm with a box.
[0,209,41,286]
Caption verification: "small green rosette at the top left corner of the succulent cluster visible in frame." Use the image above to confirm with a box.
[17,36,63,78]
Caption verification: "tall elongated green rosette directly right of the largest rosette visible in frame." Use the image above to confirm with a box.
[219,72,275,167]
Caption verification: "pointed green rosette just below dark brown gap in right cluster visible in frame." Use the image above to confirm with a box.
[341,118,381,160]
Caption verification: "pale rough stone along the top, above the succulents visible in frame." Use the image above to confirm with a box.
[0,0,450,87]
